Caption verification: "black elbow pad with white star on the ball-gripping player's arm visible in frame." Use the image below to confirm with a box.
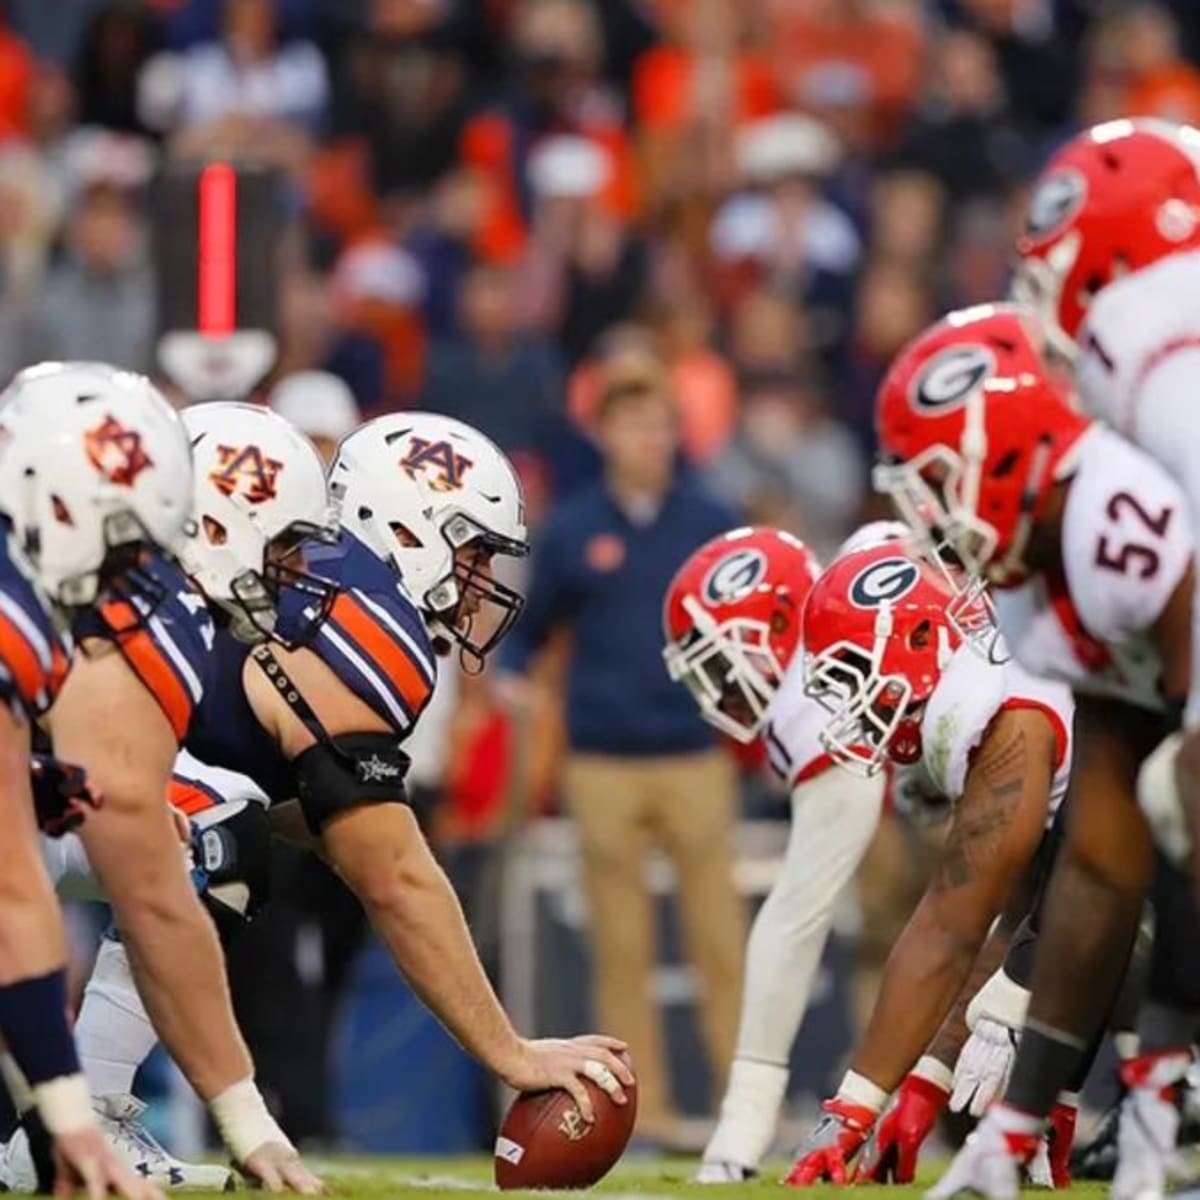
[292,733,409,836]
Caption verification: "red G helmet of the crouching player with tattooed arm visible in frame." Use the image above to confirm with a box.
[803,541,979,775]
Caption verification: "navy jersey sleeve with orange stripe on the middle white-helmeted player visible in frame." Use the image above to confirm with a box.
[74,551,215,742]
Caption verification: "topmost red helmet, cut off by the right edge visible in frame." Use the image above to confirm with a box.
[1013,118,1200,358]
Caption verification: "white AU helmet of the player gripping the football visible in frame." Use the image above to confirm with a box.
[329,413,529,662]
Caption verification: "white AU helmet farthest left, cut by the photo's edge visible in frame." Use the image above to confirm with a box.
[0,362,192,608]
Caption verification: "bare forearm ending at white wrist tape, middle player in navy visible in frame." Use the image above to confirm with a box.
[85,809,253,1100]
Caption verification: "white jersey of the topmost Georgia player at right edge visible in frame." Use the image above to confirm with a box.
[1076,251,1200,725]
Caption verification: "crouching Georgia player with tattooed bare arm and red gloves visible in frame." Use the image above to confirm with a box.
[786,544,1073,1186]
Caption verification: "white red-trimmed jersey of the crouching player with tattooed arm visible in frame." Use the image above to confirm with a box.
[920,646,1075,824]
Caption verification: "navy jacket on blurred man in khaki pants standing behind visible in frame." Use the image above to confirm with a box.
[500,480,736,755]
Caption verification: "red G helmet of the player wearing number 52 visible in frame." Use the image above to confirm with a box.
[874,305,1091,586]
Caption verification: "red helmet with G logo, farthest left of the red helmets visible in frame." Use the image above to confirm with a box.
[662,529,821,743]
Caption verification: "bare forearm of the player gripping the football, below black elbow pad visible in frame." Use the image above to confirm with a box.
[325,805,520,1075]
